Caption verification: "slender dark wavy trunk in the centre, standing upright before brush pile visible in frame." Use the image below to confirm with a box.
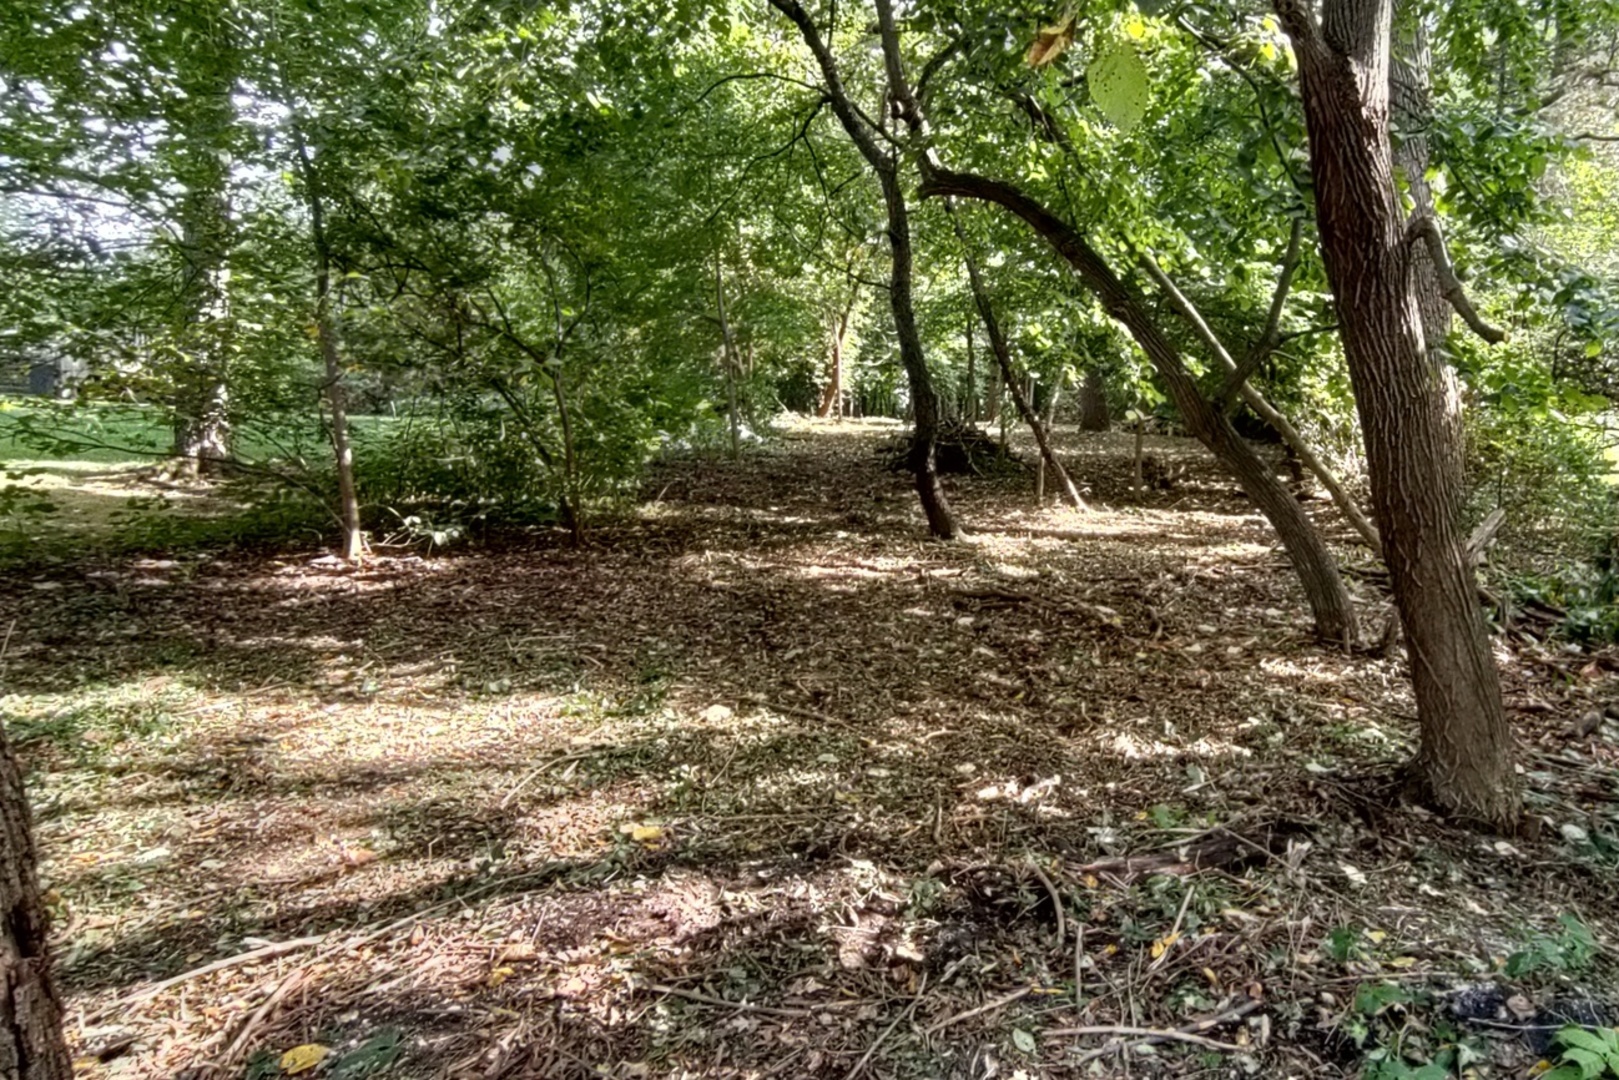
[771,0,960,539]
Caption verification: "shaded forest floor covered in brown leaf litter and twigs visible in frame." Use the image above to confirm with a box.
[0,424,1619,1080]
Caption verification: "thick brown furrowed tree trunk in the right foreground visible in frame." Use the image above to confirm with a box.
[1274,0,1520,827]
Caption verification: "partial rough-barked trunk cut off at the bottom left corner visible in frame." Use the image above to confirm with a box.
[0,725,73,1080]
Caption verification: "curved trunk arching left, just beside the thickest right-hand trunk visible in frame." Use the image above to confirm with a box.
[923,168,1357,644]
